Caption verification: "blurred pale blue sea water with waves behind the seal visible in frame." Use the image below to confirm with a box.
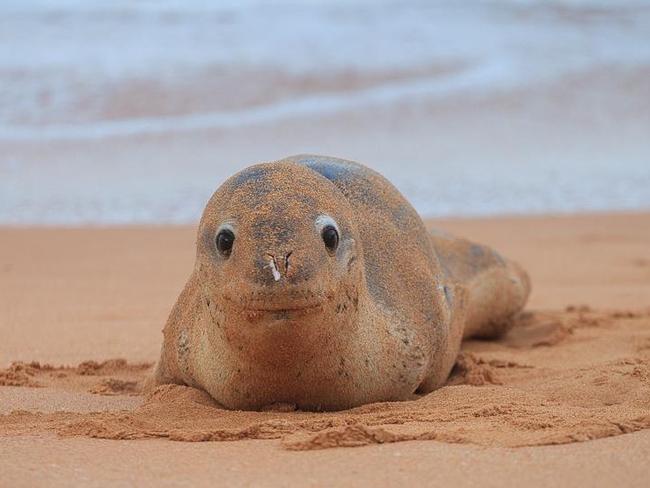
[0,0,650,225]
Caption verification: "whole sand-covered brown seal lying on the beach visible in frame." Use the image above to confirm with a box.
[149,155,530,410]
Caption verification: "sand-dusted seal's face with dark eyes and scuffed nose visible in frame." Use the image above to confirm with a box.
[196,162,362,335]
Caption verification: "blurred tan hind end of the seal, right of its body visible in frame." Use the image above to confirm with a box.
[431,232,530,338]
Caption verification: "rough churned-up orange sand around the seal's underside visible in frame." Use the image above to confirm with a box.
[0,307,650,450]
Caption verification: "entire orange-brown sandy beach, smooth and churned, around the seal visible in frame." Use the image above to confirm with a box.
[0,214,650,486]
